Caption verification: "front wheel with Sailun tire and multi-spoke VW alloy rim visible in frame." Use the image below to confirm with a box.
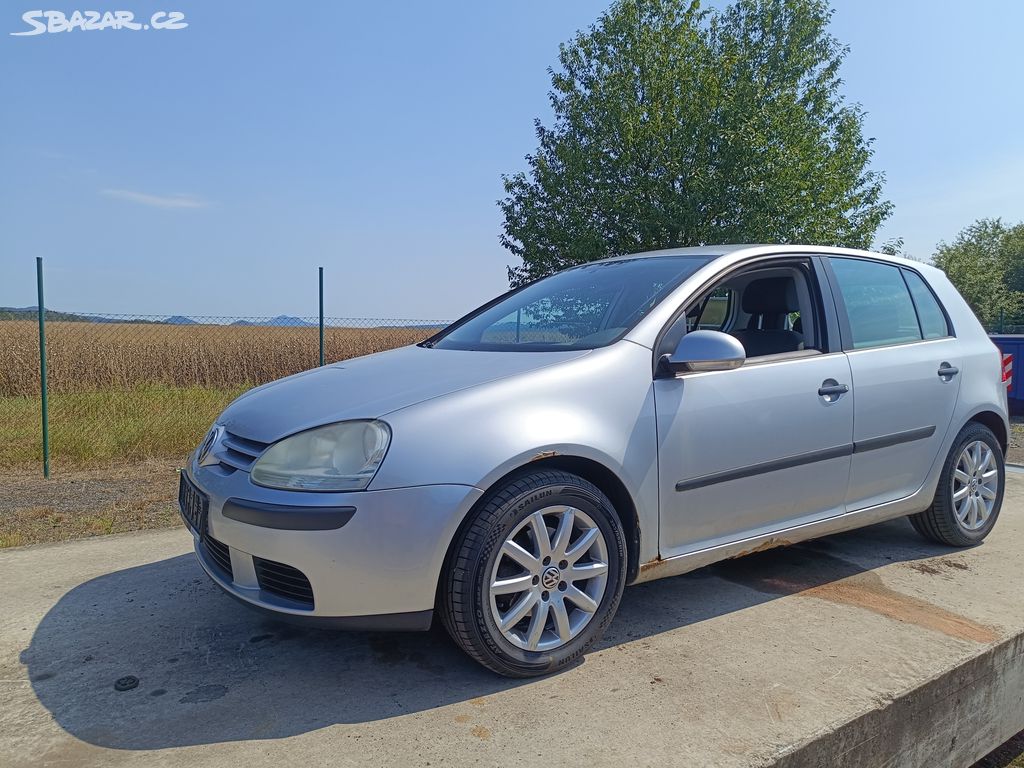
[438,470,627,678]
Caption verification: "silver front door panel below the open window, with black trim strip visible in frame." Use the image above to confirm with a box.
[654,353,853,557]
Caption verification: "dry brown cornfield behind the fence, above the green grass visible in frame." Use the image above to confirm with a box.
[0,321,433,397]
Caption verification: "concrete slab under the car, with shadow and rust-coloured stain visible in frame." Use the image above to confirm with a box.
[0,474,1024,768]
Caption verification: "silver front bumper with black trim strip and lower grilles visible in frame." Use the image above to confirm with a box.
[182,463,482,629]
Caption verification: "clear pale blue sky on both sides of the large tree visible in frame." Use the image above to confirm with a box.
[0,0,1024,319]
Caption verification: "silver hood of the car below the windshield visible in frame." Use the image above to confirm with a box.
[218,346,588,442]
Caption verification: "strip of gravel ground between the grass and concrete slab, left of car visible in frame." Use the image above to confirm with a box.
[0,460,180,548]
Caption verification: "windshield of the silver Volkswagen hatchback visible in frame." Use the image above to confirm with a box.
[427,256,715,352]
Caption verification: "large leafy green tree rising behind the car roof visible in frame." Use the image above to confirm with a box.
[499,0,892,285]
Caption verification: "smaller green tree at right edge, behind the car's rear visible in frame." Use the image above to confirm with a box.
[934,219,1024,329]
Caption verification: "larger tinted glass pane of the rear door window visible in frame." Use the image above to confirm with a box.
[829,258,927,349]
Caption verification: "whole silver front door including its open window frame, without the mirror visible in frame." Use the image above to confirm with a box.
[654,258,855,557]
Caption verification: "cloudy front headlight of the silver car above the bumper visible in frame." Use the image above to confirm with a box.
[250,421,391,490]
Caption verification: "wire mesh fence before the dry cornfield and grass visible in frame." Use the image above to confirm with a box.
[0,312,446,471]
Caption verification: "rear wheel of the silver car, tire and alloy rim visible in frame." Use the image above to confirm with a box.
[909,422,1006,547]
